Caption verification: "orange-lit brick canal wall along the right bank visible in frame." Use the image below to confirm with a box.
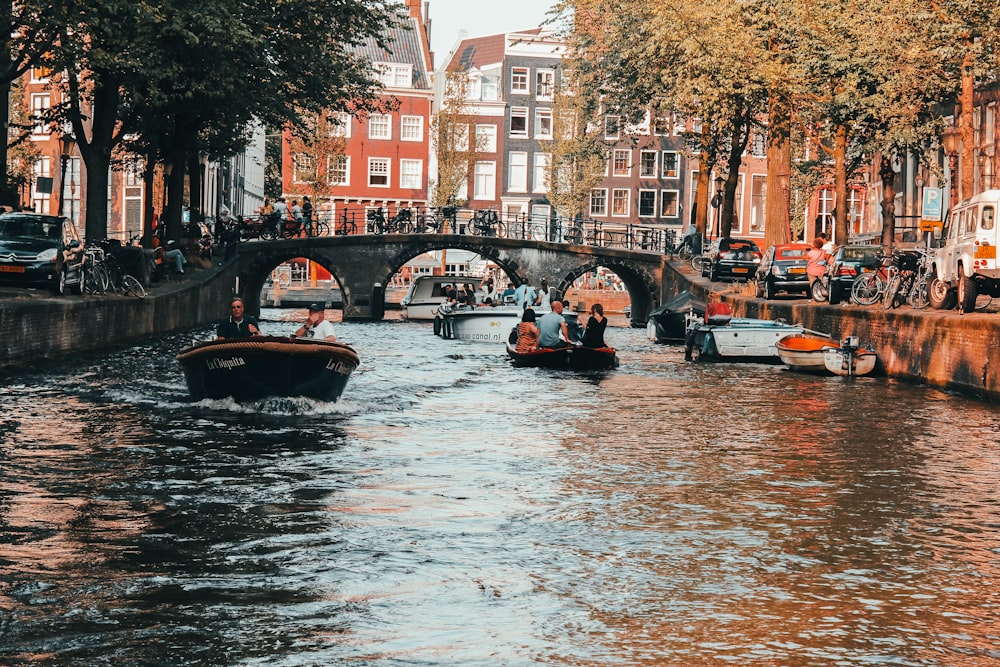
[663,263,1000,400]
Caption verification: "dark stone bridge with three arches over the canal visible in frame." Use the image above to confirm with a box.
[236,234,666,325]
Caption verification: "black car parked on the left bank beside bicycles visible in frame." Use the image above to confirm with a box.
[0,213,84,294]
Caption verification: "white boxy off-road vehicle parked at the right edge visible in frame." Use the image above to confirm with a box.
[927,190,1000,312]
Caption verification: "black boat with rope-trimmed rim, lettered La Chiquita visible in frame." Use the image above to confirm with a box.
[177,336,359,402]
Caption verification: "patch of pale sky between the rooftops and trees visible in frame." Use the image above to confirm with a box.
[428,0,555,66]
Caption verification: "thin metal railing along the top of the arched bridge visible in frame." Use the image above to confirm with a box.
[292,207,677,253]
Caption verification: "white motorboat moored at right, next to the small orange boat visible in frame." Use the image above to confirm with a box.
[684,317,805,362]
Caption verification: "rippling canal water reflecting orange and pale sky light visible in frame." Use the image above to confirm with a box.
[0,310,1000,667]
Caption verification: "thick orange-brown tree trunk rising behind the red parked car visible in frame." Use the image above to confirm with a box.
[764,97,793,246]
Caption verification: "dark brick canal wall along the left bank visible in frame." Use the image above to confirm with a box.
[0,262,236,368]
